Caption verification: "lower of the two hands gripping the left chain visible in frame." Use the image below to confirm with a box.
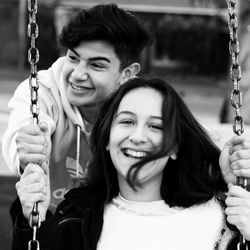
[16,163,50,221]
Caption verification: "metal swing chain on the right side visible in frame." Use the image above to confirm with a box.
[227,0,248,250]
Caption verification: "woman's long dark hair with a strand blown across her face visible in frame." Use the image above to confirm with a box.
[89,77,226,207]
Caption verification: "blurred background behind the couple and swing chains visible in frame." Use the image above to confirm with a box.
[0,0,250,250]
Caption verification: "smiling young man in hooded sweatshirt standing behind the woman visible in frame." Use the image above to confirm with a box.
[3,4,151,207]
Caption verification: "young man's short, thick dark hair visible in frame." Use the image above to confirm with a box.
[59,4,152,69]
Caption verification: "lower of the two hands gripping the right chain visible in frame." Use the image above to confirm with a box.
[225,184,250,240]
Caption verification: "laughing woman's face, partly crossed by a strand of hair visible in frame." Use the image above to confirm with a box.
[107,87,169,188]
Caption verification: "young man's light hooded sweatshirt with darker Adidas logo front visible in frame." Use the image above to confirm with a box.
[2,57,91,209]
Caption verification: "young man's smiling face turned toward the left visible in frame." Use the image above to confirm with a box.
[62,41,121,107]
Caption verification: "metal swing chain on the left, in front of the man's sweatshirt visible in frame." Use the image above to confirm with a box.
[27,0,41,250]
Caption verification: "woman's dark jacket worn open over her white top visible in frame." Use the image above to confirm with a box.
[12,187,250,250]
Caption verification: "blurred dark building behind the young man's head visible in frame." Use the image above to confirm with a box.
[0,0,228,75]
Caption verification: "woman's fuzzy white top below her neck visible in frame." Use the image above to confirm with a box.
[97,196,225,250]
